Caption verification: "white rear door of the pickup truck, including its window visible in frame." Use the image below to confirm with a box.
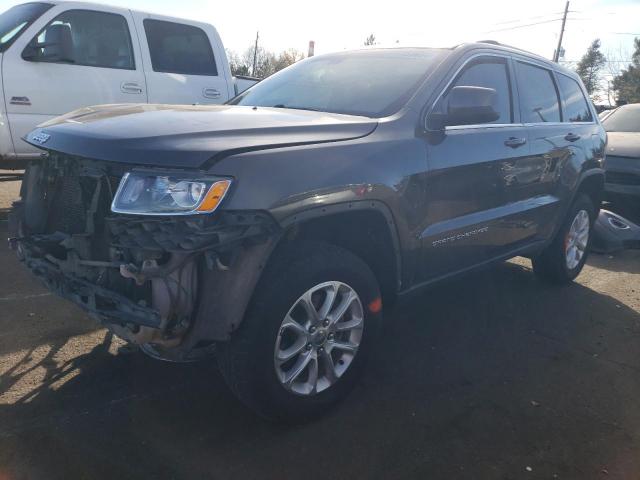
[133,12,233,104]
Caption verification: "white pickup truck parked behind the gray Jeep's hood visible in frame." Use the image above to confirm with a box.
[0,0,255,169]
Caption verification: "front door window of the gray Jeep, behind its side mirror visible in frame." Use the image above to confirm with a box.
[434,58,513,123]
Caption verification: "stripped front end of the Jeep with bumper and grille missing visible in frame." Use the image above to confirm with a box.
[10,152,279,360]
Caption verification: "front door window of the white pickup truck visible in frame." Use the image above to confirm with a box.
[22,10,135,70]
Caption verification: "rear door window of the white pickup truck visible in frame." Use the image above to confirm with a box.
[144,19,218,76]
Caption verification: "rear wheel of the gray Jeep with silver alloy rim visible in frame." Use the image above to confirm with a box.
[532,195,596,283]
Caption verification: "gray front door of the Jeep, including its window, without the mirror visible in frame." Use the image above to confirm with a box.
[421,54,529,282]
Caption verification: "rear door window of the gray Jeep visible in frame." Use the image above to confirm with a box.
[516,62,560,123]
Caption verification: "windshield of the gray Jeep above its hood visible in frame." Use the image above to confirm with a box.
[229,49,443,118]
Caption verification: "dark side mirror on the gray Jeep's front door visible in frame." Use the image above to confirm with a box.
[429,86,500,130]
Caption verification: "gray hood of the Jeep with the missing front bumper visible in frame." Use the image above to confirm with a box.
[25,104,377,168]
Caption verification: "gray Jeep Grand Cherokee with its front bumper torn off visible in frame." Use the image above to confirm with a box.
[11,42,606,420]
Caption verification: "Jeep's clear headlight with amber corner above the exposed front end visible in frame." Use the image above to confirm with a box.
[111,172,231,215]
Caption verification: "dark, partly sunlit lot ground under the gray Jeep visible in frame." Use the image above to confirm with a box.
[0,180,640,480]
